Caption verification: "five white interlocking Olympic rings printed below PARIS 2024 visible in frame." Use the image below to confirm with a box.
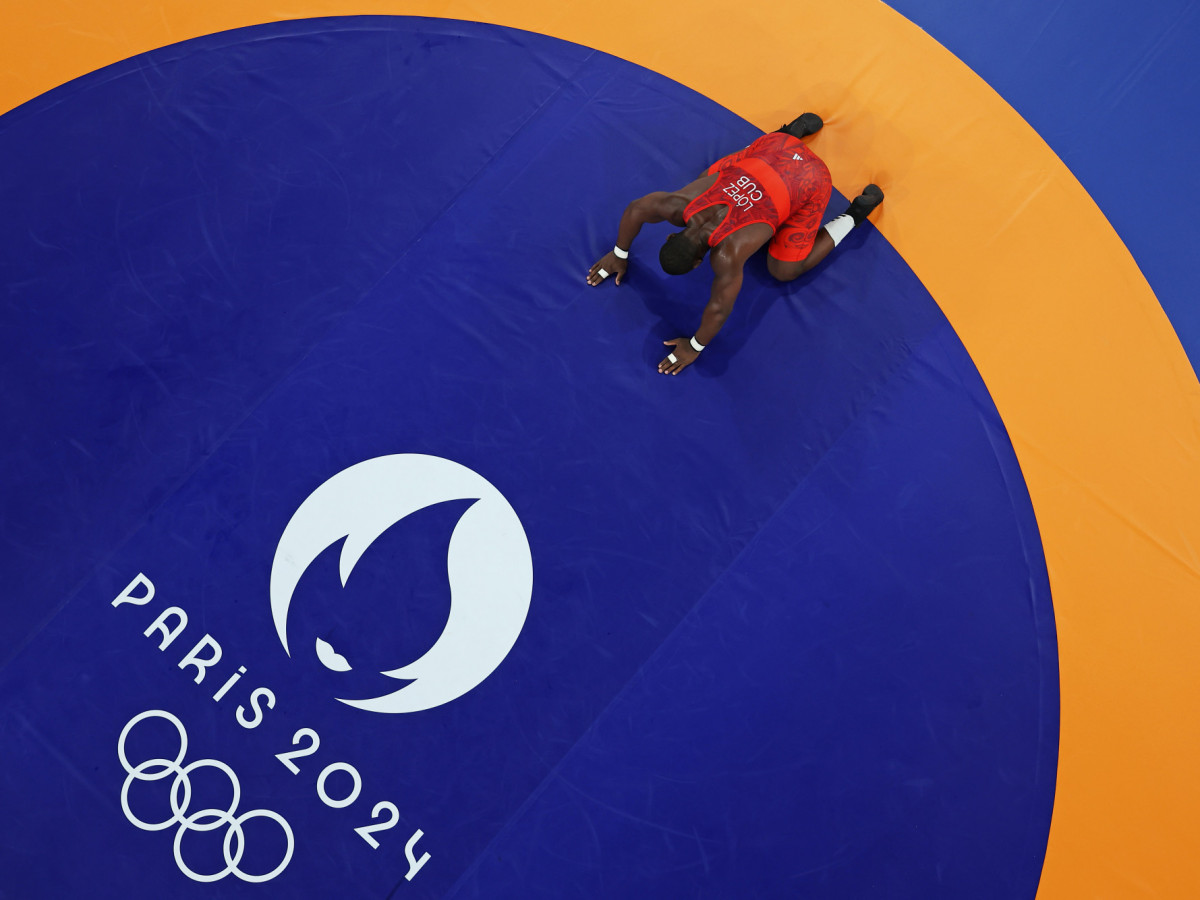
[116,709,295,882]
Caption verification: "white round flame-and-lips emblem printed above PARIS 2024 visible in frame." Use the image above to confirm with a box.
[270,454,533,713]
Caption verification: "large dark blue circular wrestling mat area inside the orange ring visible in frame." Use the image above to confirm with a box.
[0,18,1058,900]
